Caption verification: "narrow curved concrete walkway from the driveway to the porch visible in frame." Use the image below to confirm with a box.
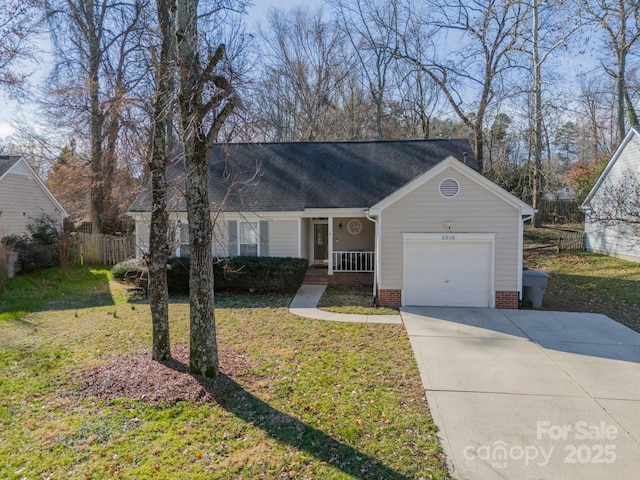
[289,285,402,324]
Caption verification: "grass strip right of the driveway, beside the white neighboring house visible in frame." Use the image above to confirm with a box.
[525,244,640,332]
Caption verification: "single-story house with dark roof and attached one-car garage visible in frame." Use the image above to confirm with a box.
[129,140,533,308]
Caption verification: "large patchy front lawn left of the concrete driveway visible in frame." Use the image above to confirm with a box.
[0,268,448,479]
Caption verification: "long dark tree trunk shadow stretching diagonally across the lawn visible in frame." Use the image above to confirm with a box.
[163,359,409,480]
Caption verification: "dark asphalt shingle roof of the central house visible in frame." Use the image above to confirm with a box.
[129,139,478,212]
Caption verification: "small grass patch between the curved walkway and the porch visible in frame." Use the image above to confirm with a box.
[318,285,399,315]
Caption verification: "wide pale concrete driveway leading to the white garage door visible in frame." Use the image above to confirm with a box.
[402,307,640,480]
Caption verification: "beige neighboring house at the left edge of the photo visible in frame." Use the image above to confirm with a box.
[0,155,67,238]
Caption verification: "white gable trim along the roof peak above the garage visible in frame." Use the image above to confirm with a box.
[369,156,533,215]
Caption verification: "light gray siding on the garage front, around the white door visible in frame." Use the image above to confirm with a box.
[380,169,521,291]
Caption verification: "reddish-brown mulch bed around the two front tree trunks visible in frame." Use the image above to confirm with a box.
[76,345,252,405]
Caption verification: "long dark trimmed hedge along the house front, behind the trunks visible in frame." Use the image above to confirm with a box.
[111,257,307,295]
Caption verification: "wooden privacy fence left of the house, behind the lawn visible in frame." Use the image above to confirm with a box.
[74,232,136,265]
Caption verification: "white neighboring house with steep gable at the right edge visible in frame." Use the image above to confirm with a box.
[582,127,640,261]
